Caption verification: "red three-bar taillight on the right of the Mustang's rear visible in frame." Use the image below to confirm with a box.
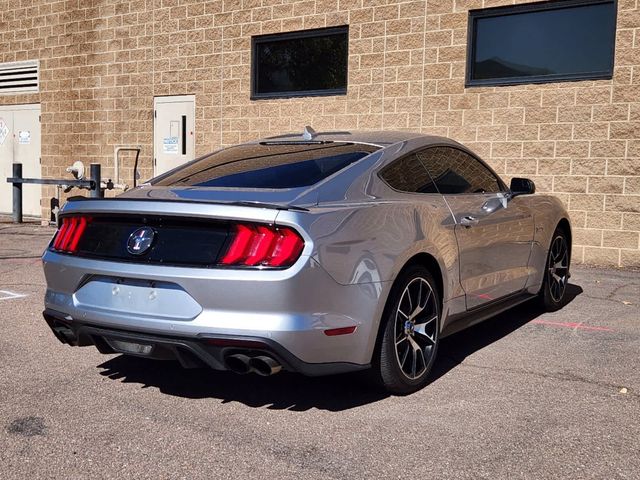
[220,224,304,267]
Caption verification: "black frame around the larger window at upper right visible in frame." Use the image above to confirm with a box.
[465,0,618,88]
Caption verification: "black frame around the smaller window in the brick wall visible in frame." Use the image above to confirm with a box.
[250,25,349,100]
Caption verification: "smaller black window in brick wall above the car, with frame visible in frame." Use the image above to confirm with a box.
[252,27,349,98]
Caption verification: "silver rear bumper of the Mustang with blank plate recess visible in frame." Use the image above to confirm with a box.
[43,250,387,372]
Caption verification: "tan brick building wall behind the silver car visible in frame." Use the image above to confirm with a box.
[0,0,640,266]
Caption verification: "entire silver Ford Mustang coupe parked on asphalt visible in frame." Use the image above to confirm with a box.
[43,128,571,394]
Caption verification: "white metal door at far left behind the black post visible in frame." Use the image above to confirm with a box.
[0,105,42,217]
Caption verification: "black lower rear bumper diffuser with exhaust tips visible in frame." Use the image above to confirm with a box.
[43,309,369,376]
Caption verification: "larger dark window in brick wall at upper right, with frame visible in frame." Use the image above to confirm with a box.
[467,0,616,85]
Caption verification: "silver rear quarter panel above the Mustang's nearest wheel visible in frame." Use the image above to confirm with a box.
[276,194,463,359]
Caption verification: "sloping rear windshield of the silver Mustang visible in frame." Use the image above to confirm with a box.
[151,142,379,189]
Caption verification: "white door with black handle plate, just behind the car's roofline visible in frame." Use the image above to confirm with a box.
[153,95,196,175]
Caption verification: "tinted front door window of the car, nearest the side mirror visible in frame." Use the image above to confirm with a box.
[418,147,501,195]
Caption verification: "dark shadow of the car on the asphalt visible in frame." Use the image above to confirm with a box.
[98,284,582,411]
